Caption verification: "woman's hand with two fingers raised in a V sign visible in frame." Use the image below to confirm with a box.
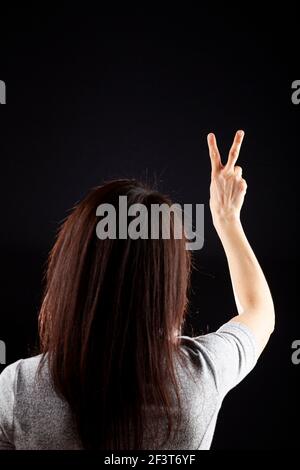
[207,131,247,226]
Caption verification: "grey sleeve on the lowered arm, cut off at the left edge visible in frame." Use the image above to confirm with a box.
[0,361,20,450]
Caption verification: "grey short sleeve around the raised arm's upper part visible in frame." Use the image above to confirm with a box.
[185,322,258,397]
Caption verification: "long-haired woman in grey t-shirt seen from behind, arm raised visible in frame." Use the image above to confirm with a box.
[0,131,274,450]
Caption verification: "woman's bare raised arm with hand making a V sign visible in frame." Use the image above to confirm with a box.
[207,131,275,354]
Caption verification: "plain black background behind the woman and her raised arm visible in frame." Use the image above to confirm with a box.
[0,6,300,449]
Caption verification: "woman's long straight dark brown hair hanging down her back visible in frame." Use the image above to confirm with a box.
[39,179,190,450]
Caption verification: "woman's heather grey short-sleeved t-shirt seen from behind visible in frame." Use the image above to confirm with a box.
[0,322,257,450]
